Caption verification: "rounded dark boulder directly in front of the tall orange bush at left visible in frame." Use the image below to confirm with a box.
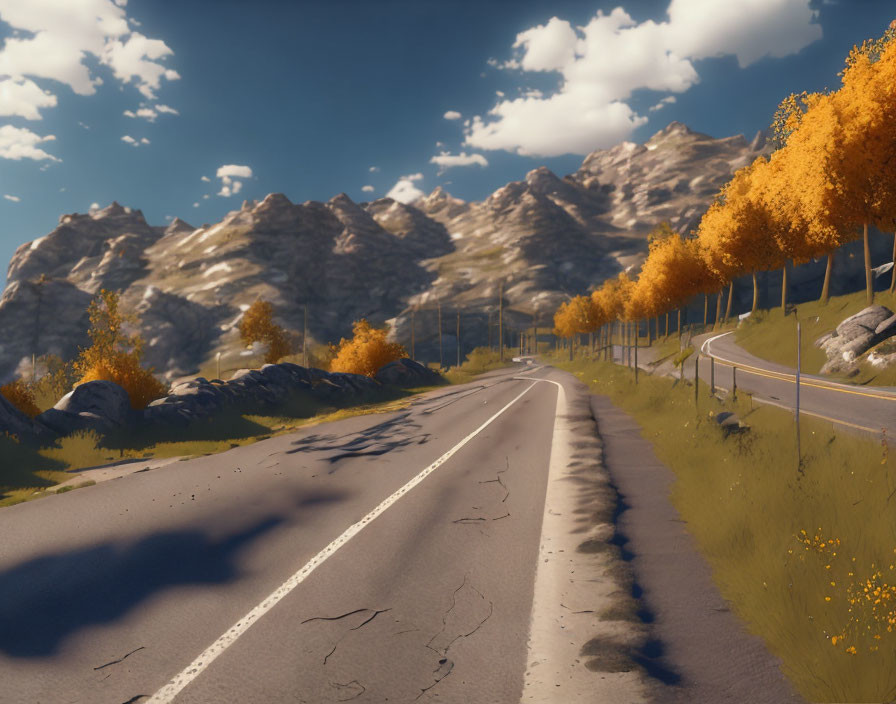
[37,381,139,435]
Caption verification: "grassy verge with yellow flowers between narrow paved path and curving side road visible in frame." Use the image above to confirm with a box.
[557,359,896,702]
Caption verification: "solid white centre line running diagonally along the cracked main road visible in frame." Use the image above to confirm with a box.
[146,382,537,704]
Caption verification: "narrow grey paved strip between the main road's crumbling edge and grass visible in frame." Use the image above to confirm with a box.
[591,395,803,704]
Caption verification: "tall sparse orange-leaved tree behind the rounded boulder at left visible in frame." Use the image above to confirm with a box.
[75,289,167,409]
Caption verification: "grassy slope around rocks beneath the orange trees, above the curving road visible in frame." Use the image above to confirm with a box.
[735,291,896,386]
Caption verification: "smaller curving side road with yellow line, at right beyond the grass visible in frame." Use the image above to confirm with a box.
[614,333,896,438]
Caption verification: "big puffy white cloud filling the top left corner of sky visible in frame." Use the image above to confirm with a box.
[0,0,179,137]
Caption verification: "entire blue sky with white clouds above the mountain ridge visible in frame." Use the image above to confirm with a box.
[0,0,896,284]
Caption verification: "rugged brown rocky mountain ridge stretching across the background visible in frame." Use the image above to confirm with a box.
[0,122,868,380]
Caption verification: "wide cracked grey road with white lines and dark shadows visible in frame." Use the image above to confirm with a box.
[0,366,647,704]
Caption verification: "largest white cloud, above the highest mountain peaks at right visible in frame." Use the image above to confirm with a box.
[464,0,821,156]
